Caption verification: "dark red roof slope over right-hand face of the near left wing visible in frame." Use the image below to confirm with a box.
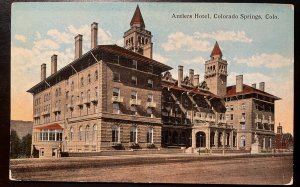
[98,45,173,71]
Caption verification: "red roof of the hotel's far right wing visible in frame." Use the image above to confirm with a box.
[225,84,280,100]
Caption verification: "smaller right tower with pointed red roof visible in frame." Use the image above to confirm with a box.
[204,42,227,96]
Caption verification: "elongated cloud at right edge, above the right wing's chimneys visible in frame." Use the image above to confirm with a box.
[233,53,293,69]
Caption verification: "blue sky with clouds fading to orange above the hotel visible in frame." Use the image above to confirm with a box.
[11,2,294,133]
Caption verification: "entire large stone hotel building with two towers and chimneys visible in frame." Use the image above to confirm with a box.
[28,7,279,157]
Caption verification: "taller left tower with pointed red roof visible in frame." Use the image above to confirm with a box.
[123,5,153,59]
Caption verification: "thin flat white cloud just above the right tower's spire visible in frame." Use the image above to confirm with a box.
[194,31,252,43]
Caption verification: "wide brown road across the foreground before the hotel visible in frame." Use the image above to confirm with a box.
[11,155,293,184]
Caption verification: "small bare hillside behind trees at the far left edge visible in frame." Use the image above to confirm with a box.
[10,120,33,138]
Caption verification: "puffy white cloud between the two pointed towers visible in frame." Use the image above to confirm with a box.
[162,32,211,51]
